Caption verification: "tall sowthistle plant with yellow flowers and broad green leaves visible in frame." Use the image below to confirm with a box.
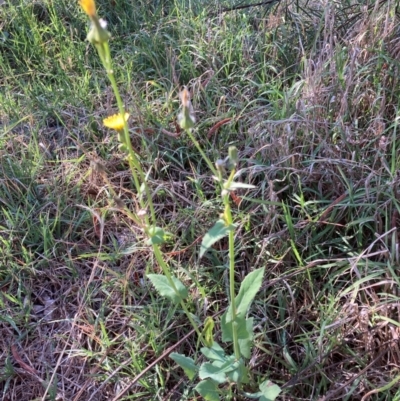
[79,0,280,401]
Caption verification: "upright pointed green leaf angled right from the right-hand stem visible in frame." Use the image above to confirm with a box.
[226,267,265,323]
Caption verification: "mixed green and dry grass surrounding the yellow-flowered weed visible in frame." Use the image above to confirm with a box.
[0,0,400,401]
